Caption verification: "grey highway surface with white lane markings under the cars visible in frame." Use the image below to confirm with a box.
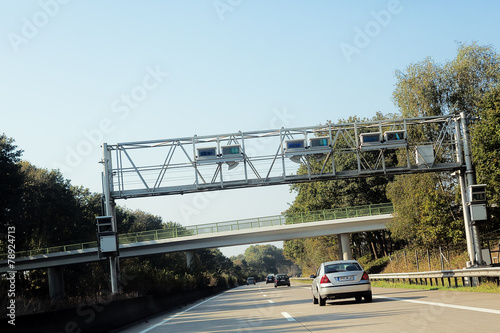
[117,281,500,333]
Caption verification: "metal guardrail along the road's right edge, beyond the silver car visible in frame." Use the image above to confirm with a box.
[370,267,500,287]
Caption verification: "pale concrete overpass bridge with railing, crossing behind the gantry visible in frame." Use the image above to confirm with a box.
[0,203,394,298]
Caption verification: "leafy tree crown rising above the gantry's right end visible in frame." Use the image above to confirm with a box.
[393,42,500,118]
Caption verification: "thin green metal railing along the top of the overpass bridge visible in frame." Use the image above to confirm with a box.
[0,203,394,260]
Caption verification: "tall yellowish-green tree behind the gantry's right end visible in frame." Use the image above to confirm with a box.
[389,43,500,244]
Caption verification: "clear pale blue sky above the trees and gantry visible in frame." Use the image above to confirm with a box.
[0,0,500,255]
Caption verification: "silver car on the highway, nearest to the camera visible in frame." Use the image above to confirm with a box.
[311,260,372,306]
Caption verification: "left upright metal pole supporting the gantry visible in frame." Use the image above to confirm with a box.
[102,143,120,294]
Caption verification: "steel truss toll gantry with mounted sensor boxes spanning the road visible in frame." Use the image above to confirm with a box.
[101,113,482,293]
